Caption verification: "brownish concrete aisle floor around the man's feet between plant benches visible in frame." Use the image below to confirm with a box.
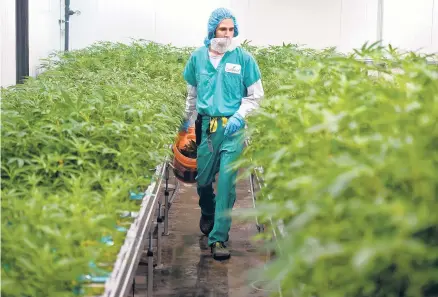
[130,171,269,297]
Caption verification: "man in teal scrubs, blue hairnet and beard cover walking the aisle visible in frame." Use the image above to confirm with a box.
[182,8,264,260]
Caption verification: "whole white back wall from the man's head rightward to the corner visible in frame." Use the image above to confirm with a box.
[240,0,377,51]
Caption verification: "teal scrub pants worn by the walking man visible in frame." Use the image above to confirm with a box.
[196,117,244,245]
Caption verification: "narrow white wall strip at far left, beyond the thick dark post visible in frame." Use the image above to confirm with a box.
[0,0,16,87]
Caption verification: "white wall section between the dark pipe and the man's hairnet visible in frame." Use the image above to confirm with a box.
[70,0,230,49]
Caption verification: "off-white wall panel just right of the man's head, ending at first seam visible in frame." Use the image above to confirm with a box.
[247,0,342,48]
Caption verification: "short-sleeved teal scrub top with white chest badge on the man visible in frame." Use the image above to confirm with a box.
[183,46,261,117]
